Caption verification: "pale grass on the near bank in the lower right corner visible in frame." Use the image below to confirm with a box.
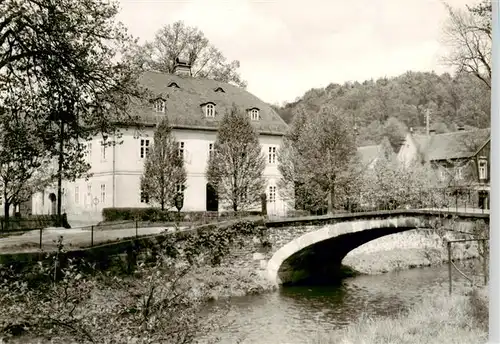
[312,289,488,344]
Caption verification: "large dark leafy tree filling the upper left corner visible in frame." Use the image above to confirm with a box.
[0,0,148,213]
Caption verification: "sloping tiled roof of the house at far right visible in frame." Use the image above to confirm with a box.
[412,128,490,161]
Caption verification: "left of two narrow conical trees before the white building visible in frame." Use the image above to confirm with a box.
[141,119,186,210]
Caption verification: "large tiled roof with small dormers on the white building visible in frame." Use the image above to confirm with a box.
[134,71,288,135]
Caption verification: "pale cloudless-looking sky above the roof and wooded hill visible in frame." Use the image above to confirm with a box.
[118,0,476,104]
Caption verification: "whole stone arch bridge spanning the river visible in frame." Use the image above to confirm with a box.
[233,210,489,285]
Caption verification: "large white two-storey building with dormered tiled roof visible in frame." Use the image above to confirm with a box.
[32,64,289,219]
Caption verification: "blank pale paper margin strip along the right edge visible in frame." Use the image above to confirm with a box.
[488,0,500,344]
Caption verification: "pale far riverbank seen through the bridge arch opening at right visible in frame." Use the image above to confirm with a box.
[342,229,478,275]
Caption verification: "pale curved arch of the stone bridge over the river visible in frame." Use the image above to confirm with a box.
[267,217,428,285]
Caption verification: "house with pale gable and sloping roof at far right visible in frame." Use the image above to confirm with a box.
[398,128,490,207]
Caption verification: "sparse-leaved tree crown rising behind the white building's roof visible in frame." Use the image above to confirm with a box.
[138,21,246,87]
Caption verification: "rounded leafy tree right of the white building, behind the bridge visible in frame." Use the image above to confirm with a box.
[295,106,356,213]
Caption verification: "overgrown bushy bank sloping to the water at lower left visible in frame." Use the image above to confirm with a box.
[0,221,274,344]
